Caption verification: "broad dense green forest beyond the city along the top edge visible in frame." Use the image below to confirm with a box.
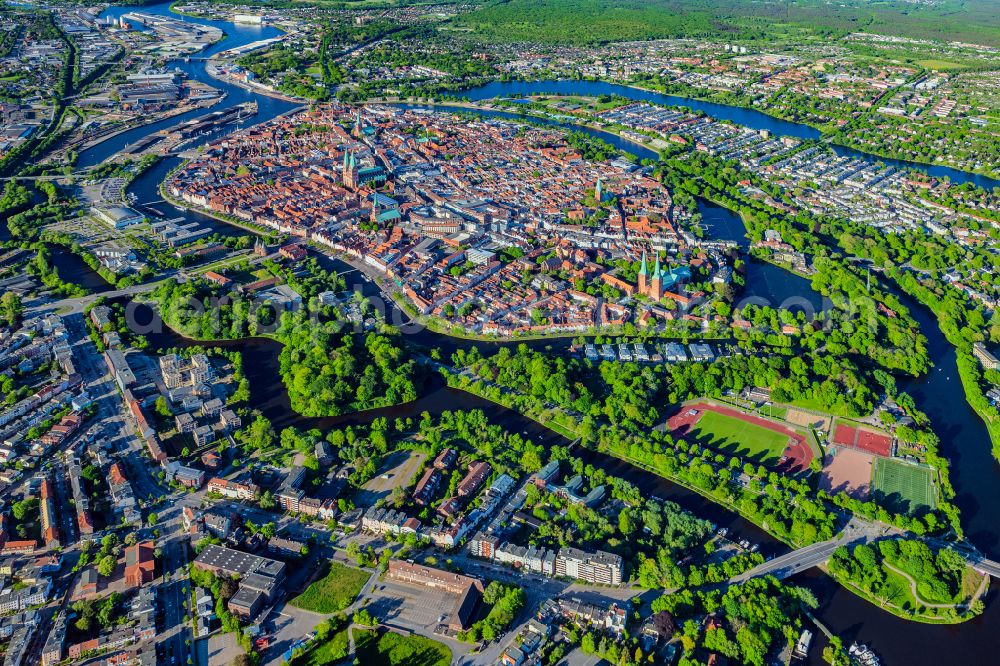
[454,0,1000,45]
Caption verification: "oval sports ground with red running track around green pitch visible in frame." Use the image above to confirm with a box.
[667,403,813,472]
